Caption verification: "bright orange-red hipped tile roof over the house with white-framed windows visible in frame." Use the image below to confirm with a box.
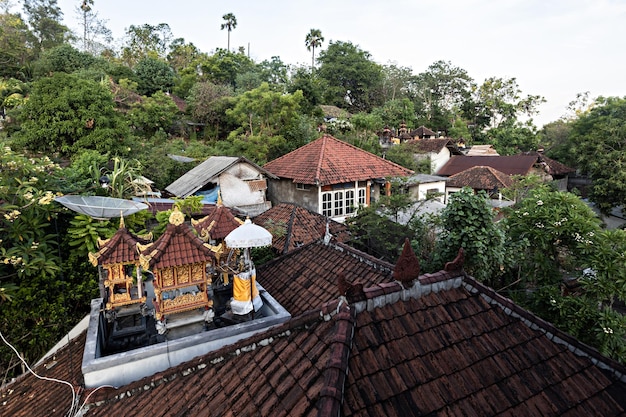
[263,135,413,185]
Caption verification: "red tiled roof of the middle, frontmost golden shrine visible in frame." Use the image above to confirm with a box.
[140,219,215,269]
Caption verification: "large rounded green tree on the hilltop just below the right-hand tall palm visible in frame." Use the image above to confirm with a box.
[318,41,382,113]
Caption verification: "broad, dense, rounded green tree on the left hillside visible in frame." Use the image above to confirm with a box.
[15,73,130,155]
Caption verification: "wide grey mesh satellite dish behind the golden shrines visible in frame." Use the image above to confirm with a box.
[55,195,148,220]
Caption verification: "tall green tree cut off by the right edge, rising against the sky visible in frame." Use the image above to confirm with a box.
[570,97,626,211]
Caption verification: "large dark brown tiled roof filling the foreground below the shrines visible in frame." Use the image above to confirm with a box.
[0,244,626,417]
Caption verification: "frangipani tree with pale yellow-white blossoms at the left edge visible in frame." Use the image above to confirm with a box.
[0,143,97,378]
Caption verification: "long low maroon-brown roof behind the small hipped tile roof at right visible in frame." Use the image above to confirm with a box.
[437,155,537,177]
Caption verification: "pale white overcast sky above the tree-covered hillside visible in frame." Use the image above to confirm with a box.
[52,0,626,127]
